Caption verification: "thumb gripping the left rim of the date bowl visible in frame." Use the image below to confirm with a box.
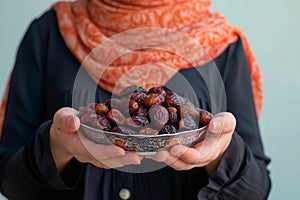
[53,107,80,133]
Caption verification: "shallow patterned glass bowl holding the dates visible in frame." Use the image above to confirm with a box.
[78,121,207,155]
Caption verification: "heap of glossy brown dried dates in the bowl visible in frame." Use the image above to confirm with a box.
[79,86,212,135]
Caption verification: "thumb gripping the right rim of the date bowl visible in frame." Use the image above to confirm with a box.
[208,112,236,134]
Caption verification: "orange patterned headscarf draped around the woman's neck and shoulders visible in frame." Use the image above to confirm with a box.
[0,0,263,134]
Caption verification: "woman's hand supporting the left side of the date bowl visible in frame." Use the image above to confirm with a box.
[50,107,142,172]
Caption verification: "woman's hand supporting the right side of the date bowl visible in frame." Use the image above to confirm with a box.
[148,112,236,175]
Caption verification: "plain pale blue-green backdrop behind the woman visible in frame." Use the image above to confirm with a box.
[0,0,300,200]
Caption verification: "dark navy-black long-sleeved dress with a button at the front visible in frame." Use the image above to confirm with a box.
[0,10,271,200]
